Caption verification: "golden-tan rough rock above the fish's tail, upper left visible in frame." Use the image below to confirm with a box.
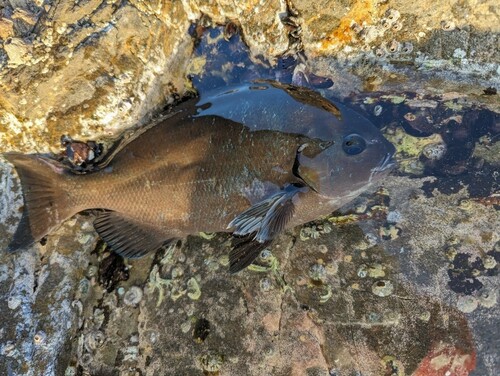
[0,1,191,151]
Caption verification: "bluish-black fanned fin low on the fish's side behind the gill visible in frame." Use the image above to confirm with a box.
[228,184,307,273]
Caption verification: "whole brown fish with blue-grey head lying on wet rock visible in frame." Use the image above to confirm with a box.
[4,80,395,273]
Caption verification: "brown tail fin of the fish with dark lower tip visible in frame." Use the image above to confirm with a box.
[4,153,73,252]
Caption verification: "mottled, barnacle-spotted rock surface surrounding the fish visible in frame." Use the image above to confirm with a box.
[0,0,500,376]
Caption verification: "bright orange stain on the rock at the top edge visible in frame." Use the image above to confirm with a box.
[320,0,376,52]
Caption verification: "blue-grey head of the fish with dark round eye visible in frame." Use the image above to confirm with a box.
[294,109,395,204]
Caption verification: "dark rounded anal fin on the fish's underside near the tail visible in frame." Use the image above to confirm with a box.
[94,212,173,258]
